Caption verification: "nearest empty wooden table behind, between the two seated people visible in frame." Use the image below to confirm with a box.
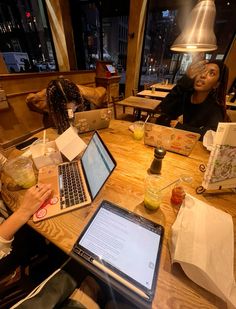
[114,96,161,119]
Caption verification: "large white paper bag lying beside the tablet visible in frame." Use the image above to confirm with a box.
[170,195,236,308]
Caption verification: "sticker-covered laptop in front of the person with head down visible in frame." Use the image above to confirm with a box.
[74,108,111,133]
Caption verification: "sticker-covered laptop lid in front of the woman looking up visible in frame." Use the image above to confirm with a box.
[144,123,200,156]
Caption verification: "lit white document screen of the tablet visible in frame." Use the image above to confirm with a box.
[79,208,160,289]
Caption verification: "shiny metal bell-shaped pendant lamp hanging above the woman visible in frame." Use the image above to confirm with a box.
[170,0,217,52]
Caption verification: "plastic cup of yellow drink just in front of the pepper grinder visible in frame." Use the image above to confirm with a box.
[144,175,162,210]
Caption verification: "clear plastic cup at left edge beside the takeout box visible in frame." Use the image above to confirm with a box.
[4,157,36,189]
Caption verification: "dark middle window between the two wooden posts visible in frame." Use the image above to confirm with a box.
[70,0,129,89]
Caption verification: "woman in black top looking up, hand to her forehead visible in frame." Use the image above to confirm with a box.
[157,60,228,139]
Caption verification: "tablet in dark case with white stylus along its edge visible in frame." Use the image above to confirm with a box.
[71,201,164,308]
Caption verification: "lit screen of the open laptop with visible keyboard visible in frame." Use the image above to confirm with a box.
[81,132,116,199]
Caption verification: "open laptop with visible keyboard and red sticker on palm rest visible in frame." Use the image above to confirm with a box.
[33,132,116,222]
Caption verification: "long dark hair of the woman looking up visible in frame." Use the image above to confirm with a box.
[209,60,229,120]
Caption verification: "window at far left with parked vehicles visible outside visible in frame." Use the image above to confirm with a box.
[0,0,56,73]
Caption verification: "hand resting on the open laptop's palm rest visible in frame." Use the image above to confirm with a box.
[17,183,52,222]
